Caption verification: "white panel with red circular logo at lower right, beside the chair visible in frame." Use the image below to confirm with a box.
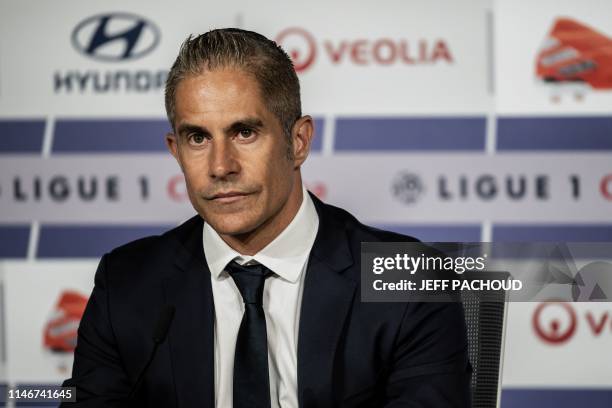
[503,302,612,388]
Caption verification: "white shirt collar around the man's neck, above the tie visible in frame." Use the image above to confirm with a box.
[202,186,319,283]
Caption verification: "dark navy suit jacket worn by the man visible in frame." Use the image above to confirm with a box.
[64,195,471,408]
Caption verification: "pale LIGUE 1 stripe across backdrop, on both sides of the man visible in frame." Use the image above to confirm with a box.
[0,153,612,225]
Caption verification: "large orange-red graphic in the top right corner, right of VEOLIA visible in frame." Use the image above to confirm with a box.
[536,18,612,101]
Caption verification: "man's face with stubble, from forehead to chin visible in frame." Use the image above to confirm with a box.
[166,69,311,236]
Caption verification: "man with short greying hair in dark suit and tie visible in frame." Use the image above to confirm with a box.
[64,29,471,408]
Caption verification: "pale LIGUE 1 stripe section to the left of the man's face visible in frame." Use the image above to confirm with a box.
[0,153,194,224]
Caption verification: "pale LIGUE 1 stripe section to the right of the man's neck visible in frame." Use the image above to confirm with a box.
[305,153,612,224]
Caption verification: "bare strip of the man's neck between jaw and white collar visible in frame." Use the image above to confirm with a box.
[220,173,304,256]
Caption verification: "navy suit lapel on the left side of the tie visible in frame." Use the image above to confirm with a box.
[164,216,215,407]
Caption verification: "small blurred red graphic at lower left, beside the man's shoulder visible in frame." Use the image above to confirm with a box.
[43,290,87,353]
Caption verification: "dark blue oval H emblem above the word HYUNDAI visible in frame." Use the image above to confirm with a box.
[72,13,161,62]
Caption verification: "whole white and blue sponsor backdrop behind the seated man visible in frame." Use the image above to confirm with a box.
[0,0,612,408]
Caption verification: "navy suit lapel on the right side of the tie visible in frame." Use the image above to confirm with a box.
[298,195,357,408]
